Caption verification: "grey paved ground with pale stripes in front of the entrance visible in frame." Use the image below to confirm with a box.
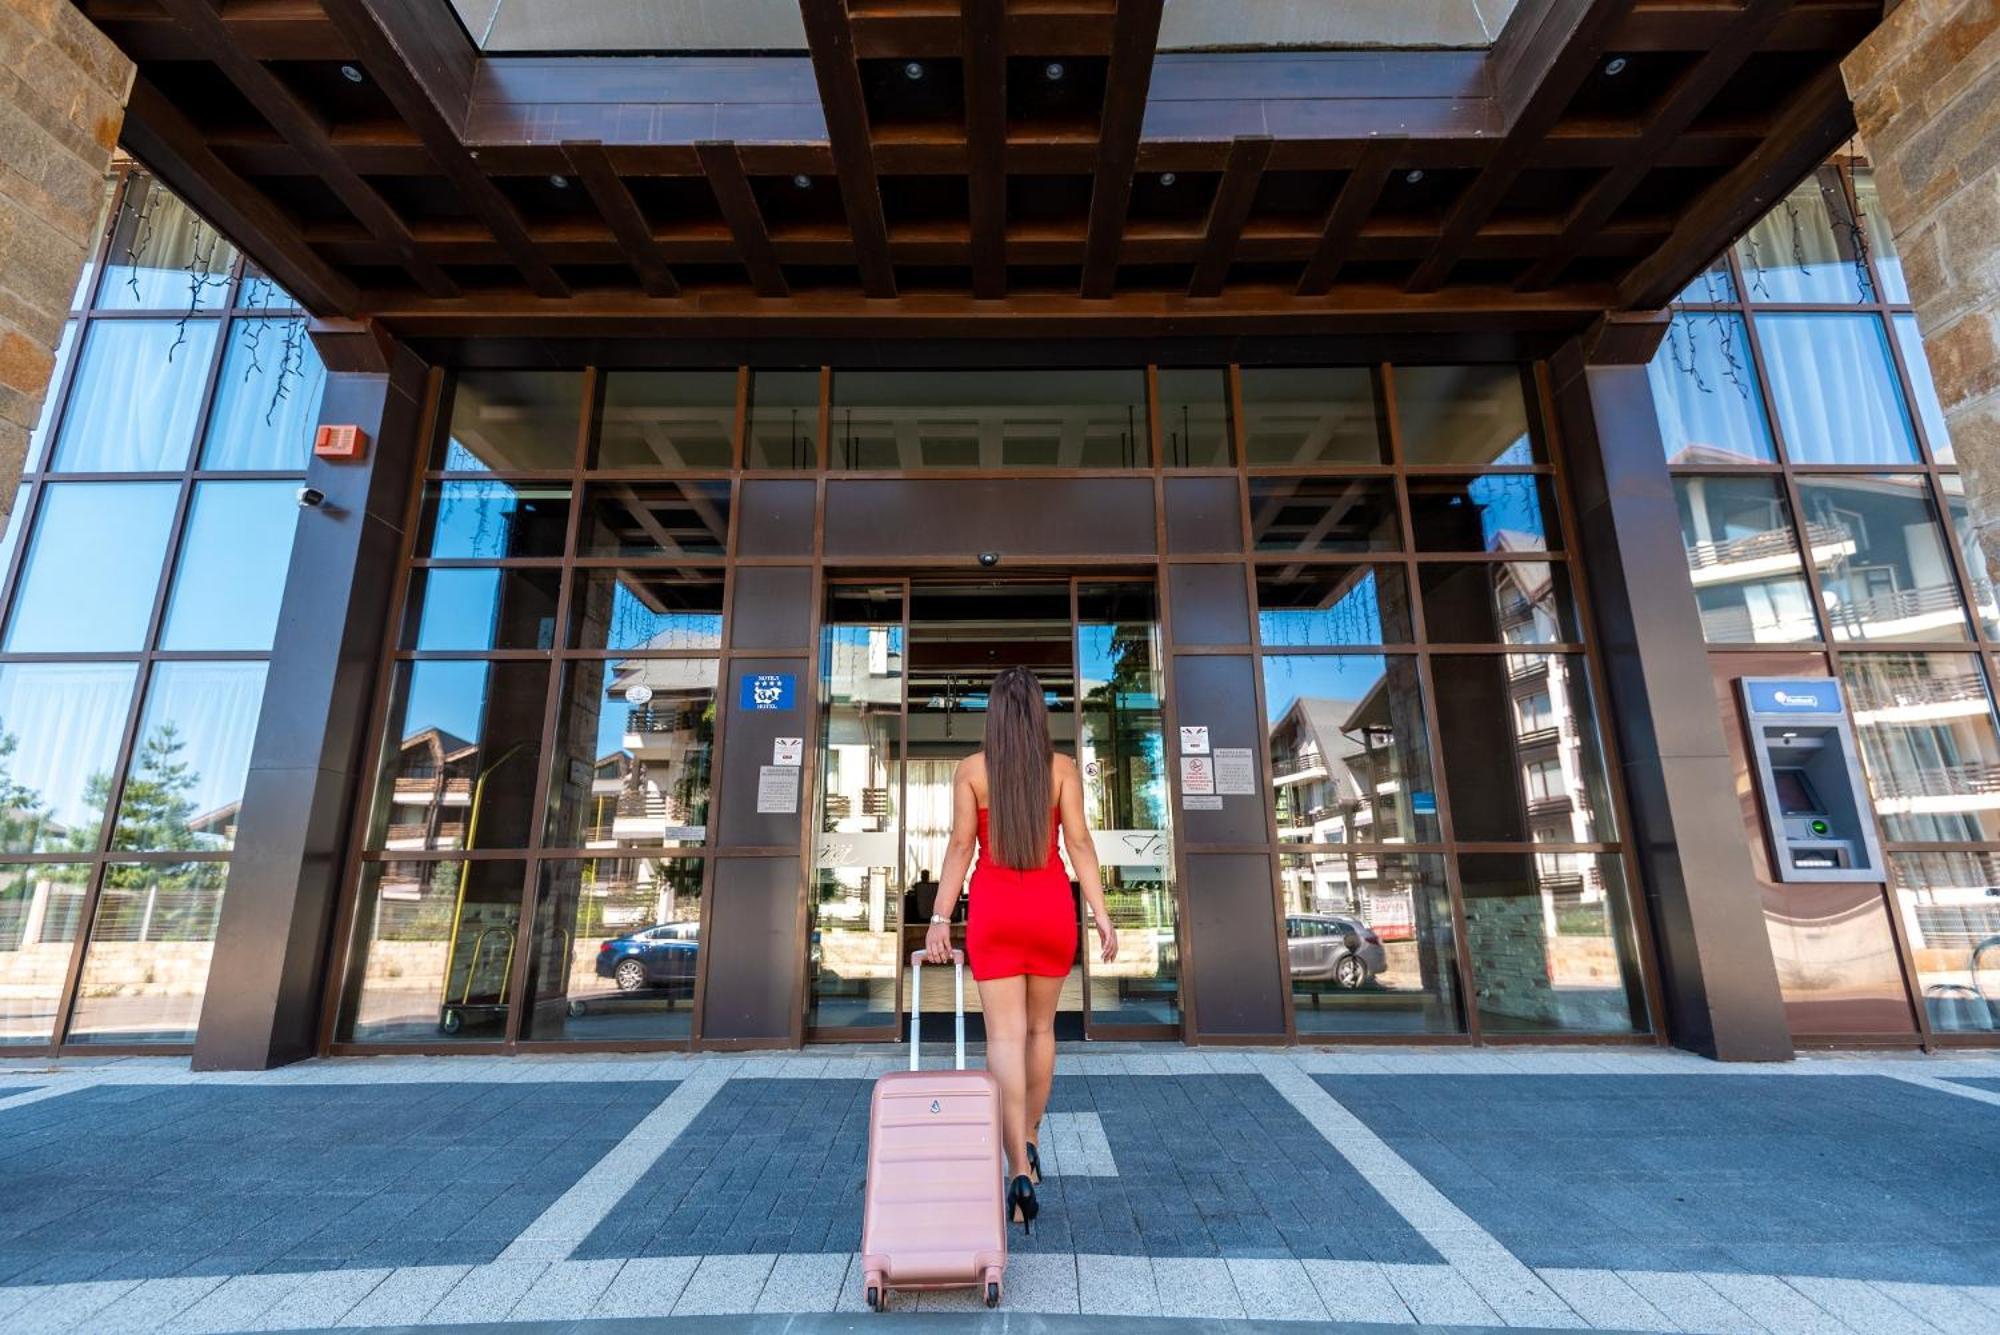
[0,1045,2000,1335]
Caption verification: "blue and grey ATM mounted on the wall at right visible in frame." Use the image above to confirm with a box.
[1736,677,1888,881]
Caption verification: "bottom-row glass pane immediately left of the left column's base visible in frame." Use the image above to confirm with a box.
[66,861,230,1043]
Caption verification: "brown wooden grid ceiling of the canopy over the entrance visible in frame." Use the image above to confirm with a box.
[78,0,1882,338]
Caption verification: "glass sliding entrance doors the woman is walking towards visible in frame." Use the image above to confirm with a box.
[806,578,1180,1039]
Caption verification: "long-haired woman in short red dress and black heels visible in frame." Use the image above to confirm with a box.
[924,668,1118,1227]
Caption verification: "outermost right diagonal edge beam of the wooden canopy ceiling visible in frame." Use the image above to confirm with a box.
[1618,62,1854,310]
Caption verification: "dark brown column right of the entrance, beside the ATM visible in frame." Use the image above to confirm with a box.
[1550,314,1792,1061]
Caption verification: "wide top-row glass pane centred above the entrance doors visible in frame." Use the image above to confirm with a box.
[830,370,1150,470]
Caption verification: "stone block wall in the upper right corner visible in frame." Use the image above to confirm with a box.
[1842,0,2000,574]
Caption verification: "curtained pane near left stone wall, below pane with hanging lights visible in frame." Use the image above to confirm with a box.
[52,320,220,474]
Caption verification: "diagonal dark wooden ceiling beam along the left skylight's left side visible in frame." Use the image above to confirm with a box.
[320,0,570,296]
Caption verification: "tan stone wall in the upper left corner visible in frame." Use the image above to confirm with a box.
[0,0,132,524]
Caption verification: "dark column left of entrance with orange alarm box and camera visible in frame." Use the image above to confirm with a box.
[194,324,428,1071]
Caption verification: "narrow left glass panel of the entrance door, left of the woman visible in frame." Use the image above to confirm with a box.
[806,586,908,1031]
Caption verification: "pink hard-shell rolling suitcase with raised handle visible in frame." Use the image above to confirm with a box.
[862,951,1006,1311]
